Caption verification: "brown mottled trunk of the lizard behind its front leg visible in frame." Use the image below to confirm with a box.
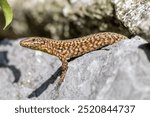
[57,32,127,59]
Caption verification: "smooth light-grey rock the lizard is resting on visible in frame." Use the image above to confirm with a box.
[0,36,150,99]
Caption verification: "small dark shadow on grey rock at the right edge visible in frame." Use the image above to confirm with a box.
[139,43,150,61]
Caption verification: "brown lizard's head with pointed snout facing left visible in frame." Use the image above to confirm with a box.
[20,37,46,50]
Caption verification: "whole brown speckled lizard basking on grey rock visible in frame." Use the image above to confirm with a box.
[20,32,127,84]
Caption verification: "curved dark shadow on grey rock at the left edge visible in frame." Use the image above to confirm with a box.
[0,51,21,83]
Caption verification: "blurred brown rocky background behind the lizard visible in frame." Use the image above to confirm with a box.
[0,0,129,39]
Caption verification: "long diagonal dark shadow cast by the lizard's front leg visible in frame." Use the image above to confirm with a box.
[28,67,61,98]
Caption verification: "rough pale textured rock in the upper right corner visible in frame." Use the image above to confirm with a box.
[112,0,150,42]
